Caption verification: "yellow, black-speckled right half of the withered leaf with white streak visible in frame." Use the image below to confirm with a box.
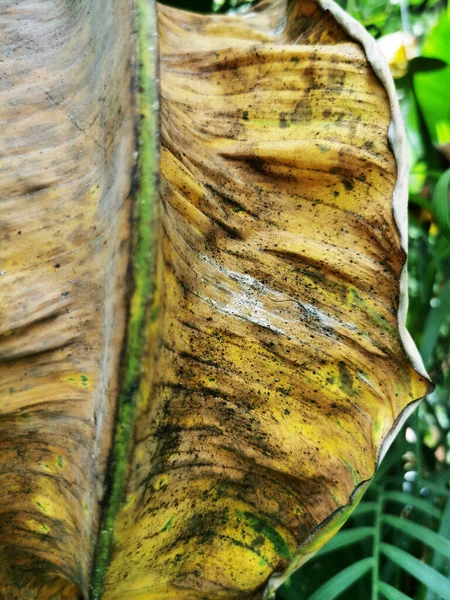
[100,0,427,600]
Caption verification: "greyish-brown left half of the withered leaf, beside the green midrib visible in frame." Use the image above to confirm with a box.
[0,0,135,600]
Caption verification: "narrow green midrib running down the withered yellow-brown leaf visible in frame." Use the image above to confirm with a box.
[91,0,158,600]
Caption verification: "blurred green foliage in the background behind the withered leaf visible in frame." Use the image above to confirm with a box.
[163,0,450,600]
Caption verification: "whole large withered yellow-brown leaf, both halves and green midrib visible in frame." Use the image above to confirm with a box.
[0,0,429,600]
